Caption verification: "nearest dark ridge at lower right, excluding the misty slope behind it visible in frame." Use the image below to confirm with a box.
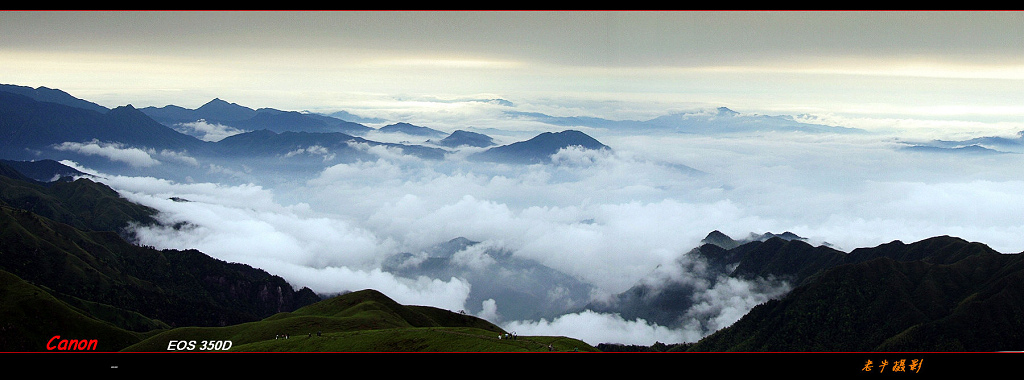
[690,237,1024,351]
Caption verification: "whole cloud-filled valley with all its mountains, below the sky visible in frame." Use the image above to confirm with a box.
[0,85,1024,351]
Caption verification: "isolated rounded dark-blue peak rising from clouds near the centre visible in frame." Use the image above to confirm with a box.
[470,130,610,164]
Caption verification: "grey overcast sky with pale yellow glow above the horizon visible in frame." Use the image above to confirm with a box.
[6,11,1024,131]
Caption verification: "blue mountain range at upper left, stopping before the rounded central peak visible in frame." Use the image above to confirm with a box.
[0,87,445,166]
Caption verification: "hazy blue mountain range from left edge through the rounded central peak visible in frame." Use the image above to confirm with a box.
[0,85,608,172]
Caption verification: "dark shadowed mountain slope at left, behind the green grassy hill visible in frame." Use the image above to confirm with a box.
[0,165,319,338]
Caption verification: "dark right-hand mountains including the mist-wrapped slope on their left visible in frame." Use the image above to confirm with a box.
[587,231,1024,351]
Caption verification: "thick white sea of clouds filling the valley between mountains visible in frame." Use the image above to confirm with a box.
[66,123,1024,344]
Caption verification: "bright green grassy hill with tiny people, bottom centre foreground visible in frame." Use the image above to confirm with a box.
[125,290,596,352]
